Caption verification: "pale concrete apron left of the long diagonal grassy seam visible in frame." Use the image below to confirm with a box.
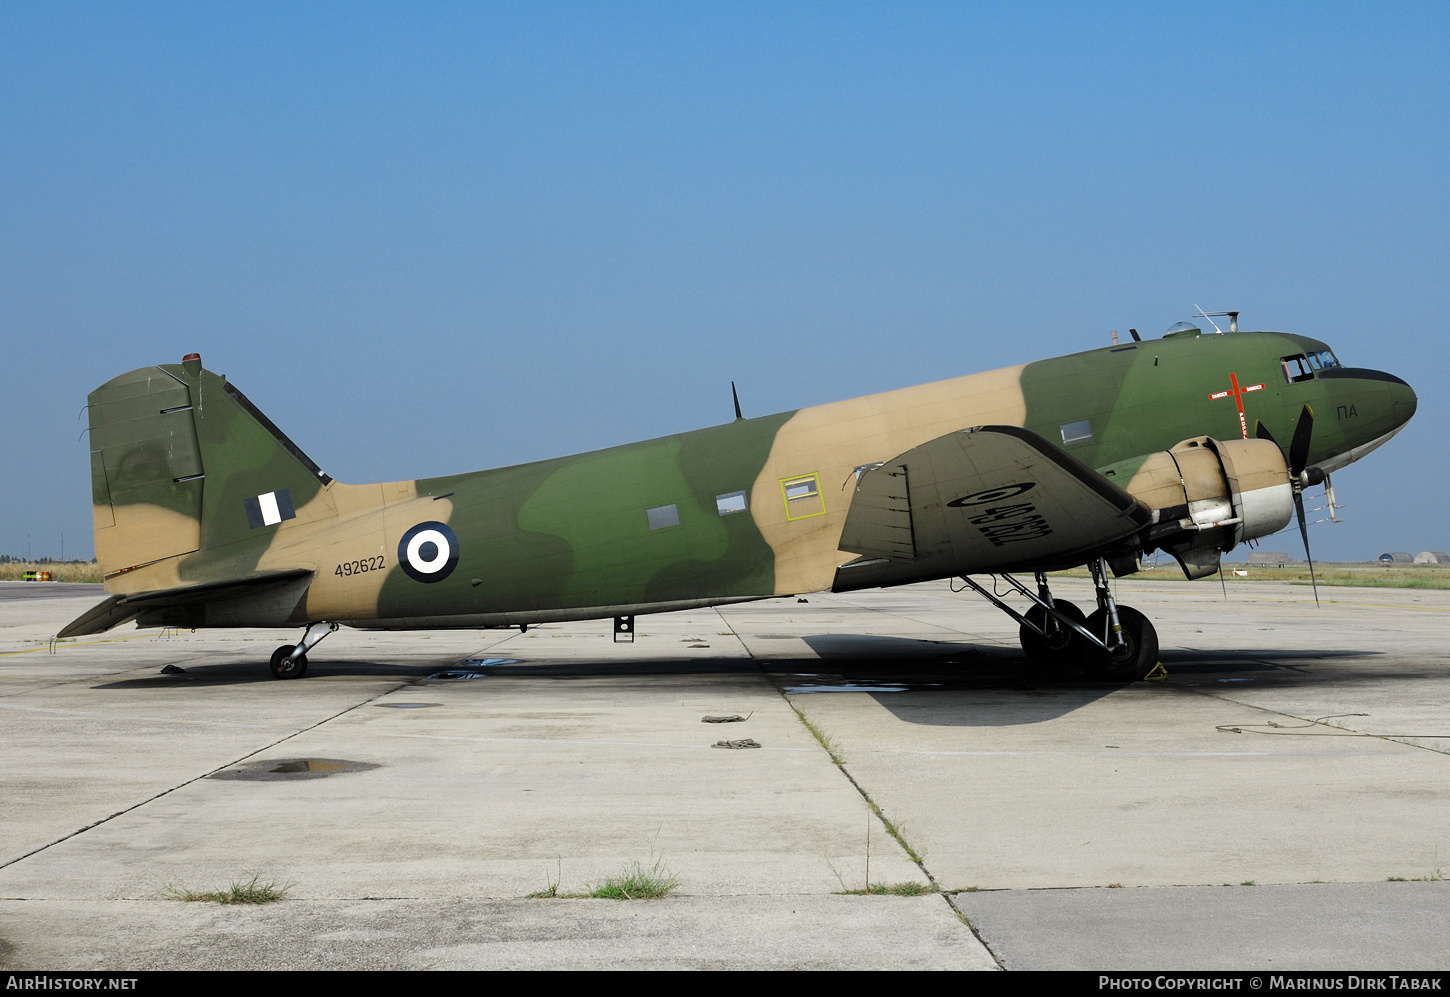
[0,588,995,968]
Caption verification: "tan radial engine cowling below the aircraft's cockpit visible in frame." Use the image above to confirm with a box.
[1127,436,1293,578]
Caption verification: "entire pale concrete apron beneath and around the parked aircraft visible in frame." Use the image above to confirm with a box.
[0,580,1450,968]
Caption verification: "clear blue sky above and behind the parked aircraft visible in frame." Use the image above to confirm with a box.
[0,3,1450,559]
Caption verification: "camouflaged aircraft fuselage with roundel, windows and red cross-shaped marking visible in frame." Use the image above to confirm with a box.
[93,333,1415,627]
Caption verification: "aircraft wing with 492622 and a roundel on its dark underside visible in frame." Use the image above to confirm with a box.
[841,426,1150,579]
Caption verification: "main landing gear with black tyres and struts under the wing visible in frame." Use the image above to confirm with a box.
[963,558,1159,683]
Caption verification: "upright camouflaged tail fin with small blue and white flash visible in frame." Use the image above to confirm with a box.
[88,354,332,587]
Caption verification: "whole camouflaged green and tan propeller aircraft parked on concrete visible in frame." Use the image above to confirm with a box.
[58,313,1417,680]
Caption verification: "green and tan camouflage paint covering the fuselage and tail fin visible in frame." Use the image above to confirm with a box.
[90,333,1415,626]
